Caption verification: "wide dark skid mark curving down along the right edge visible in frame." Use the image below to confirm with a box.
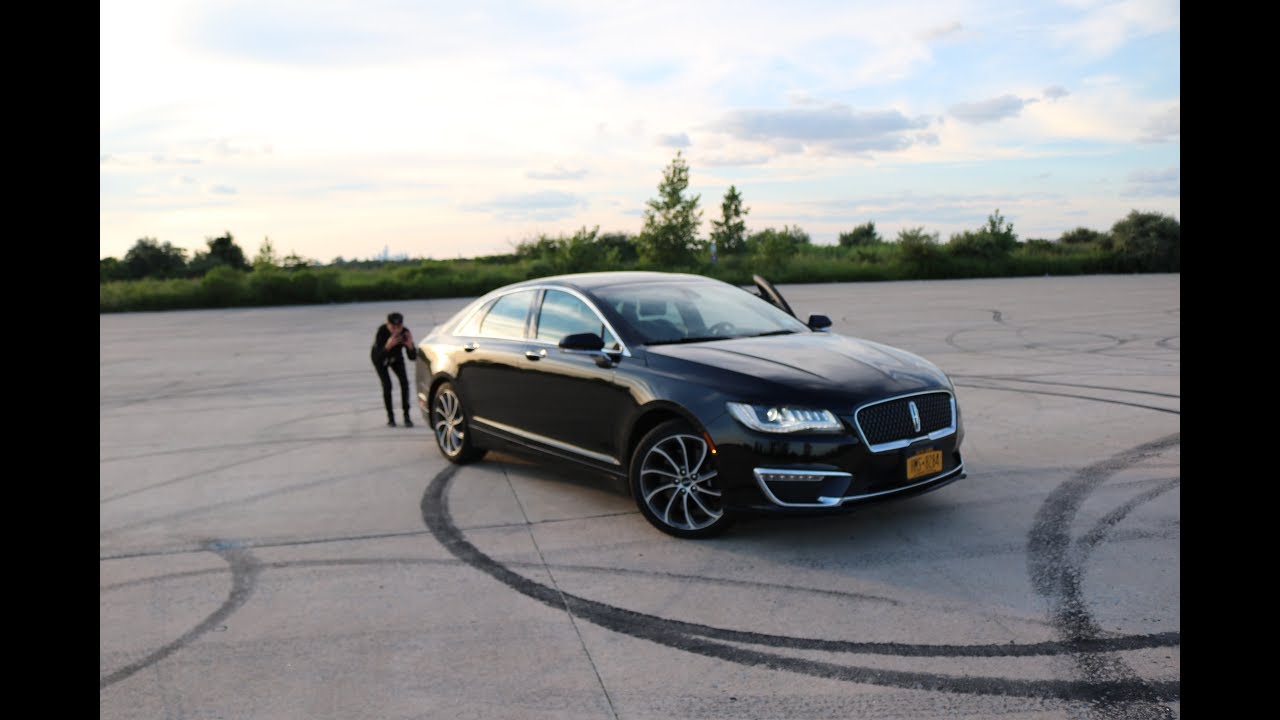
[1027,433,1181,719]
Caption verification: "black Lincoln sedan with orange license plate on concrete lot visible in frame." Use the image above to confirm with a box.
[415,272,964,537]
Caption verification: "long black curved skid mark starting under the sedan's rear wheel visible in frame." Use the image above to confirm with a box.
[422,465,1179,702]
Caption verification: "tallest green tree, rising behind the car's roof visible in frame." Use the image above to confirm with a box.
[636,151,703,268]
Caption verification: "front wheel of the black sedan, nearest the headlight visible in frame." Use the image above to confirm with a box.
[630,420,733,538]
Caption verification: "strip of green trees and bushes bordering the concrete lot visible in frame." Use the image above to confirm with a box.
[99,152,1181,311]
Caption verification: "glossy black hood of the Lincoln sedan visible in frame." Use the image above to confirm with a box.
[645,333,951,401]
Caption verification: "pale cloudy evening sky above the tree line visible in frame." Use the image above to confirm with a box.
[99,0,1181,264]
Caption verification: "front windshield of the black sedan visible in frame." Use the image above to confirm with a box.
[595,281,809,345]
